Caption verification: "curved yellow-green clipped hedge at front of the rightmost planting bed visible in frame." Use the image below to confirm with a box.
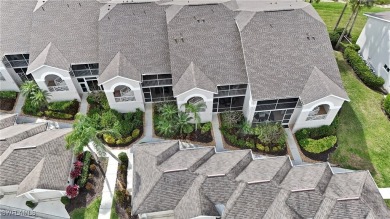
[299,135,337,154]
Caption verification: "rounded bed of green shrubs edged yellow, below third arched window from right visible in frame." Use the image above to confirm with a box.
[87,92,144,147]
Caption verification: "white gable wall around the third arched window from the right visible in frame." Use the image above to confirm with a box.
[102,76,145,113]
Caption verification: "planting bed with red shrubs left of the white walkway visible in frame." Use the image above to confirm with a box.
[65,152,108,213]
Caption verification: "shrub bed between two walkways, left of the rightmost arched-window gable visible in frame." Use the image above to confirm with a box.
[220,111,287,155]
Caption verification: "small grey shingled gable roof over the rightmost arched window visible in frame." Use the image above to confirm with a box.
[300,67,349,104]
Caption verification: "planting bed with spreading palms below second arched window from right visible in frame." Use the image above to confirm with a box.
[153,102,213,143]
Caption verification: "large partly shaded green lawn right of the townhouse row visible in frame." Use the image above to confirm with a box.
[331,52,390,190]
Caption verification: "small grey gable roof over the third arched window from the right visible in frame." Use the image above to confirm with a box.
[99,52,141,84]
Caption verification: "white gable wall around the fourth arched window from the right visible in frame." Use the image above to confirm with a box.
[31,66,80,102]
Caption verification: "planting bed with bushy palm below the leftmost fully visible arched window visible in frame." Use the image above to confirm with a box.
[21,81,80,120]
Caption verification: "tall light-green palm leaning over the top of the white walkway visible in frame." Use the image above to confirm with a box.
[65,113,121,162]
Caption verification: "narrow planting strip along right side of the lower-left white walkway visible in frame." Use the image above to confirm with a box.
[110,152,138,219]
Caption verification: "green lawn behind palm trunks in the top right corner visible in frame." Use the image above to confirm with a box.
[313,2,390,42]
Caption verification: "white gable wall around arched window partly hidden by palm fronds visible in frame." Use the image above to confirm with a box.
[176,88,214,123]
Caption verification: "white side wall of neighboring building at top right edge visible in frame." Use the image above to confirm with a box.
[356,17,390,92]
